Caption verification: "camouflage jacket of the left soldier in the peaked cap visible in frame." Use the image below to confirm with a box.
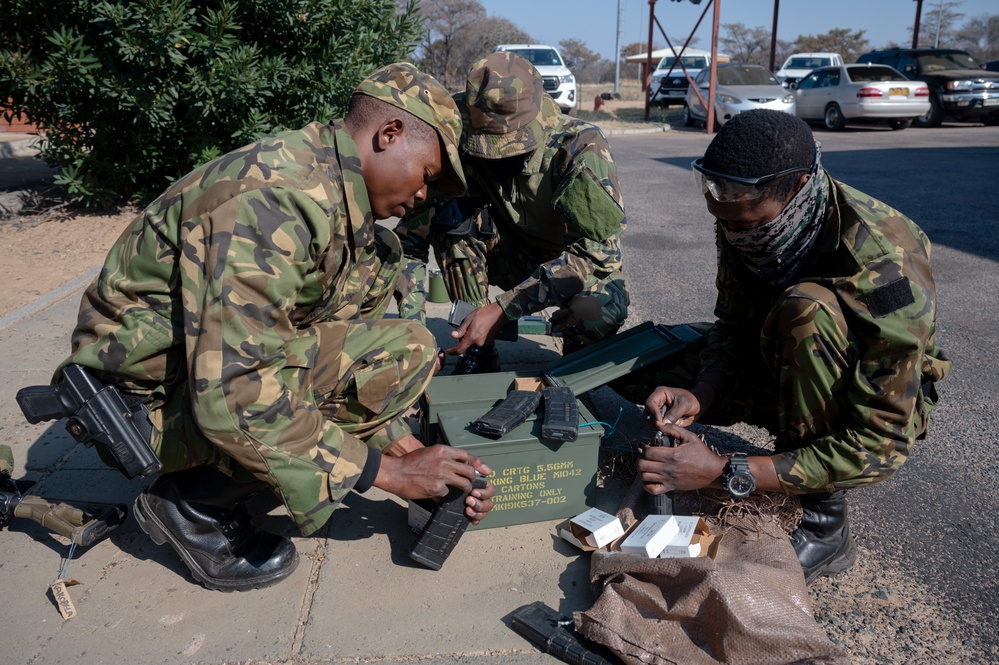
[66,123,390,534]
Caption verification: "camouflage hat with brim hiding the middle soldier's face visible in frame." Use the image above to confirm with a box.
[462,51,562,159]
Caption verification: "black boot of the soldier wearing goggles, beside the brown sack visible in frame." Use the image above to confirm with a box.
[791,491,857,584]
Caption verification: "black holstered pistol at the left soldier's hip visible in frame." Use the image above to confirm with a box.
[17,365,163,478]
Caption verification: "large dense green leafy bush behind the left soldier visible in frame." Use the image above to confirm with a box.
[0,0,422,206]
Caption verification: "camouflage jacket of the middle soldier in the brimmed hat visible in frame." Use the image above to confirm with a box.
[396,93,627,319]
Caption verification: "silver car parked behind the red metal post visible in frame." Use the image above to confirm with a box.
[683,64,794,128]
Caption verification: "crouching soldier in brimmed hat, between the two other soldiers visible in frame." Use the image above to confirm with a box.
[396,52,628,374]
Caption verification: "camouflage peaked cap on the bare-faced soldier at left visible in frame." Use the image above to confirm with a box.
[354,62,468,195]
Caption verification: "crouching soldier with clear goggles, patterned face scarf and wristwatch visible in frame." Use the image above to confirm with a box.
[613,111,951,582]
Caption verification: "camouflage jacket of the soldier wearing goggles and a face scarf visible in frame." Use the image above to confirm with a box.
[698,178,951,493]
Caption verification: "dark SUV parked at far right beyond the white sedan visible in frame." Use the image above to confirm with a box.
[857,48,999,127]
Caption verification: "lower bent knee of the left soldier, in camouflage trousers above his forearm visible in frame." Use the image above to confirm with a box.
[313,319,437,450]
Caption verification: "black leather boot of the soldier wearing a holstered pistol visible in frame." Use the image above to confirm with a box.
[135,467,298,591]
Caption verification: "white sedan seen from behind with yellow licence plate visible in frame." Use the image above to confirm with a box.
[794,64,930,130]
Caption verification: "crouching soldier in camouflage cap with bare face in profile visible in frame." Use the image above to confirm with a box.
[57,63,494,591]
